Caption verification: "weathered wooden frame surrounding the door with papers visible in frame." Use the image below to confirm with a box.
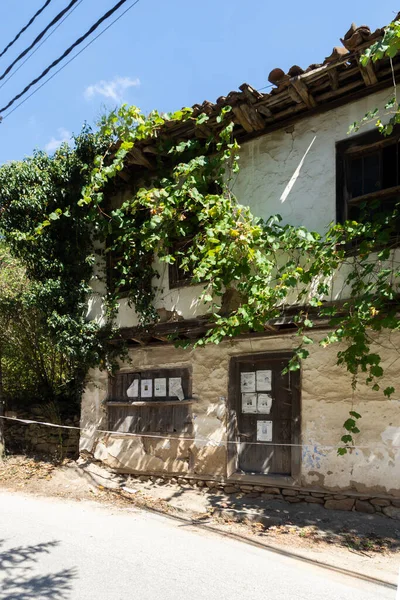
[227,352,301,485]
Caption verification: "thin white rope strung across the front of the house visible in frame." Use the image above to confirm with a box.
[0,415,400,450]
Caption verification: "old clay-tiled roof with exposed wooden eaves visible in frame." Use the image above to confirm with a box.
[129,18,400,167]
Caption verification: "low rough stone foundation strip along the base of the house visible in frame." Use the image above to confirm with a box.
[129,475,400,520]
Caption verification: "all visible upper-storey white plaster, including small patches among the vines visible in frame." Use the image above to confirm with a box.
[88,90,392,327]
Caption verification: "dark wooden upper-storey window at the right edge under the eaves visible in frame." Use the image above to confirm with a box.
[337,131,400,233]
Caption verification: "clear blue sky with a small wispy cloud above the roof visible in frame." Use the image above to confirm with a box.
[0,0,397,163]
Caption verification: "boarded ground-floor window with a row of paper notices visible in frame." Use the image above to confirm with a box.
[108,369,193,433]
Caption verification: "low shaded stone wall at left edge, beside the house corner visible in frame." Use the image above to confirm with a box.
[4,406,79,458]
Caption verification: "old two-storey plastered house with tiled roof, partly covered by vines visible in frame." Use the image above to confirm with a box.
[81,25,400,514]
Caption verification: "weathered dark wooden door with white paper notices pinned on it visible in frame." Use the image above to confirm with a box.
[230,354,300,476]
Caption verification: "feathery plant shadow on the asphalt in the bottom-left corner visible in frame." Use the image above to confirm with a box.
[0,540,77,600]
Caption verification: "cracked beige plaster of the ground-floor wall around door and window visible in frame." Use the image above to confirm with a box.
[81,333,400,496]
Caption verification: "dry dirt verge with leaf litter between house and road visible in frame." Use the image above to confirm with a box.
[0,456,400,585]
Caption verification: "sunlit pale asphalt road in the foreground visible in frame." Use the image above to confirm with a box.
[0,492,396,600]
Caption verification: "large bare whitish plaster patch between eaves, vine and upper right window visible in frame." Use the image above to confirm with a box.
[233,90,393,233]
